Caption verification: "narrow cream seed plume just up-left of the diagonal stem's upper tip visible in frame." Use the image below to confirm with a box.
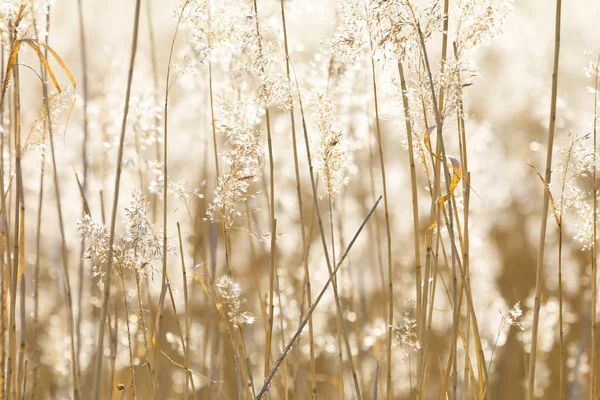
[310,93,348,201]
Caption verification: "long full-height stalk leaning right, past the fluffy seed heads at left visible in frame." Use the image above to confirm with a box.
[93,0,142,400]
